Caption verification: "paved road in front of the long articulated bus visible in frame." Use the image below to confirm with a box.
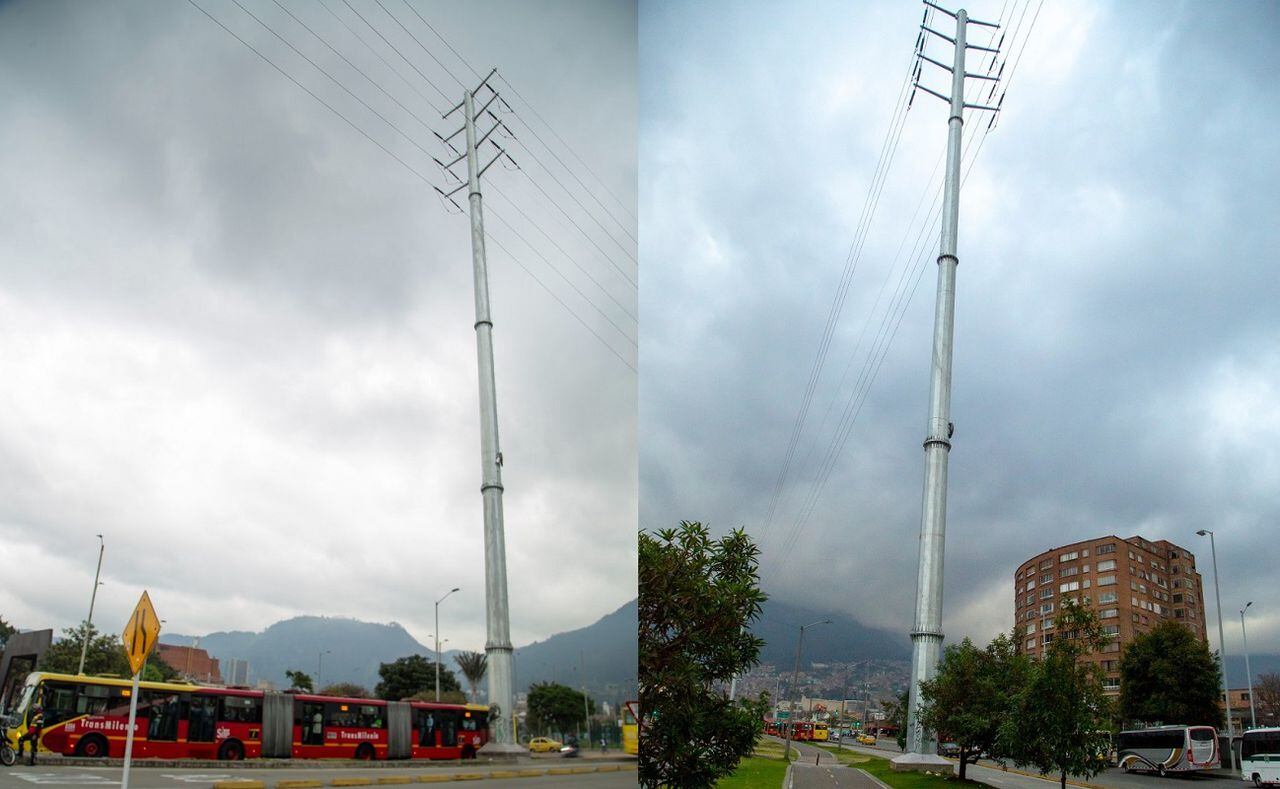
[0,763,636,789]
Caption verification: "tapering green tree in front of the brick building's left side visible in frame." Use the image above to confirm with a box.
[998,598,1111,789]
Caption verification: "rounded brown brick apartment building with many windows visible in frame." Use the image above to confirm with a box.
[1014,535,1208,693]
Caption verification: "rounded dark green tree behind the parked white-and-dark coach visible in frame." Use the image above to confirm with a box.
[1120,620,1222,729]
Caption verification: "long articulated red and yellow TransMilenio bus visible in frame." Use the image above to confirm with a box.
[9,671,489,760]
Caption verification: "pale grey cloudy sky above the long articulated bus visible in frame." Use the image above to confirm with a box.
[0,0,637,649]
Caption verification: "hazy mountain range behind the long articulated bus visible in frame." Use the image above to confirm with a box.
[160,601,637,701]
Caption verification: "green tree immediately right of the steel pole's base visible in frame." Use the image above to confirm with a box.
[920,631,1030,780]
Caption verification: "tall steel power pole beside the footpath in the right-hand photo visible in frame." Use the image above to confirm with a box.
[893,0,998,770]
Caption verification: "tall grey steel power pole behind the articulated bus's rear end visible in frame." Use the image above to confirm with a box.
[438,69,520,752]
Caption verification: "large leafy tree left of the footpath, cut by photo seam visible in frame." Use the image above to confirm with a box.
[639,521,765,786]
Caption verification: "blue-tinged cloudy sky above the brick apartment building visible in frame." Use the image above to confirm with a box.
[640,0,1280,653]
